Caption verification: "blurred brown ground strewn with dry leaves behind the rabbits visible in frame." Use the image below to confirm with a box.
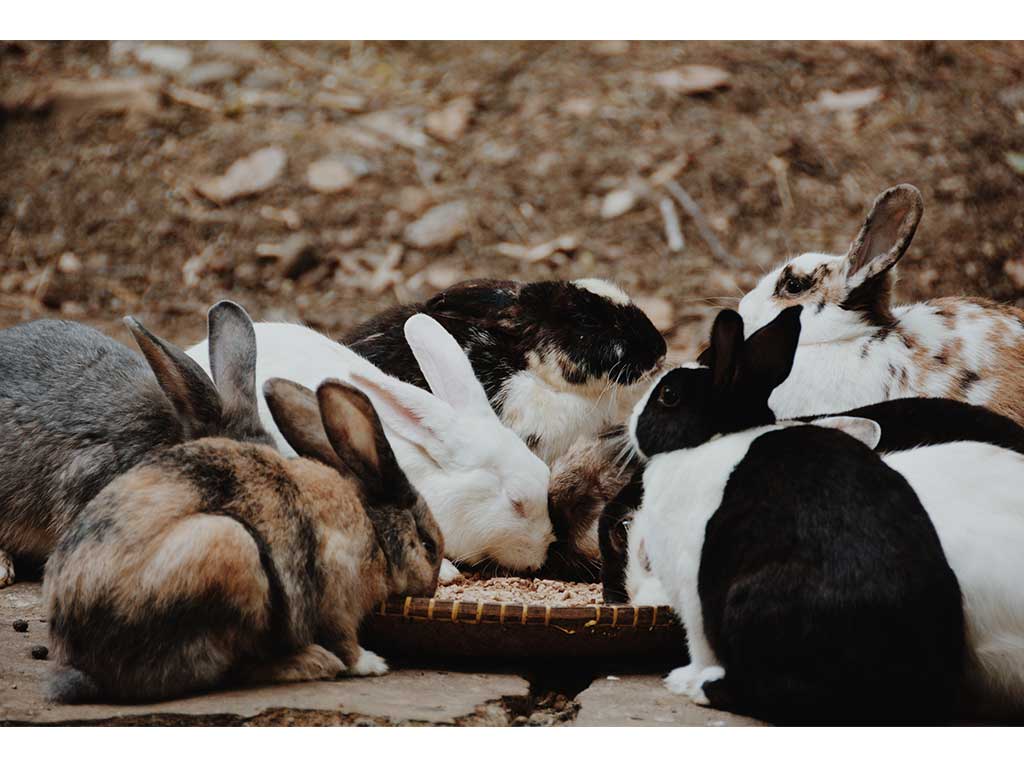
[0,42,1024,356]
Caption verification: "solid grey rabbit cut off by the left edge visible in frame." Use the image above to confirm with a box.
[0,301,272,587]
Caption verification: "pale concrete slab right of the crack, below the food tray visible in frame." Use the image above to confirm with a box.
[573,675,764,726]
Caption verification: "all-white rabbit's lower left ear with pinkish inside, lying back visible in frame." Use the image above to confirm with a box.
[350,373,456,461]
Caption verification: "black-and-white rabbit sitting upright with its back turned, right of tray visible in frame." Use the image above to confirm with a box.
[630,307,965,724]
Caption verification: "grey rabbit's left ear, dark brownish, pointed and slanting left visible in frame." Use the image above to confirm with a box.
[124,316,223,434]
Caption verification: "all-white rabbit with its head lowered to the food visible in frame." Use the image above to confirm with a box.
[187,314,554,581]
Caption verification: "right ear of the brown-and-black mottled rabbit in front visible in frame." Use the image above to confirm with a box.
[316,379,409,499]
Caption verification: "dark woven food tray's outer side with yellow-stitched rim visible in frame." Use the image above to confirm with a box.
[364,597,686,660]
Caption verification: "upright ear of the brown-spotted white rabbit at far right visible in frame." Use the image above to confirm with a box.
[846,184,925,289]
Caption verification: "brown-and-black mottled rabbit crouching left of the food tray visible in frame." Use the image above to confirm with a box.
[43,379,443,702]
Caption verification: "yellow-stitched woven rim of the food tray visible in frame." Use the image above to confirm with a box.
[377,597,678,632]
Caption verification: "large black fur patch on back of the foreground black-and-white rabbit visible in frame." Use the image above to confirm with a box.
[698,427,965,725]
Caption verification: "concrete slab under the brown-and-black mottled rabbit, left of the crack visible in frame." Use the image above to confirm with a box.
[0,583,529,725]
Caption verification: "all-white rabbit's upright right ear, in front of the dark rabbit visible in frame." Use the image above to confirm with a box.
[406,314,494,414]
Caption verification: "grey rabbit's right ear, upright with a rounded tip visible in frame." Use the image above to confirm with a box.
[207,301,258,417]
